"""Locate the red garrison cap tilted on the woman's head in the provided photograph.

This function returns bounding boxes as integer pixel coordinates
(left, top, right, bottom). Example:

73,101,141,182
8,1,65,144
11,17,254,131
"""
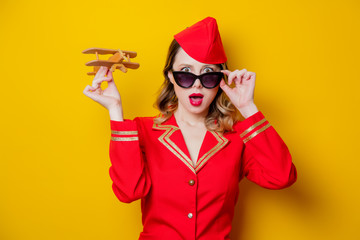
174,17,227,64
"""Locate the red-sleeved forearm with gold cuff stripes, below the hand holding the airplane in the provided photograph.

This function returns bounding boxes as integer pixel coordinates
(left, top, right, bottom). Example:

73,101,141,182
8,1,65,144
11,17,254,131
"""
109,120,151,203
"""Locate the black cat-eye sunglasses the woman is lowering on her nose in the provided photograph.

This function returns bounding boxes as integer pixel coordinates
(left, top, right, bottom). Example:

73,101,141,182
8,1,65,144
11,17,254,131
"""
172,71,224,88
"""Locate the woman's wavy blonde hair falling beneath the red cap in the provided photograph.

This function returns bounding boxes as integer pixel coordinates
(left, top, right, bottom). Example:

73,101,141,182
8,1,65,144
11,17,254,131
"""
154,39,239,133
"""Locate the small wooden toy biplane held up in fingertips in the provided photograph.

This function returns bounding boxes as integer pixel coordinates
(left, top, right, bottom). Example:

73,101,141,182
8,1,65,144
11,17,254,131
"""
82,48,140,75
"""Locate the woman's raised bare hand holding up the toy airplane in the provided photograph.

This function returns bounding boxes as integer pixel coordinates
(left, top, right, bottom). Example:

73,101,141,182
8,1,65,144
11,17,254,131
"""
83,66,122,120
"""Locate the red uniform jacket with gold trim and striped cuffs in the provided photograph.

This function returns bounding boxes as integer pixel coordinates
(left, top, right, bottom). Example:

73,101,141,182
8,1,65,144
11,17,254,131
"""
110,112,297,240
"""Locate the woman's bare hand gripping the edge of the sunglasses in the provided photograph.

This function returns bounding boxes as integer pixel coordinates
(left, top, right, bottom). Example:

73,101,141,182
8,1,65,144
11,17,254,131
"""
220,69,258,118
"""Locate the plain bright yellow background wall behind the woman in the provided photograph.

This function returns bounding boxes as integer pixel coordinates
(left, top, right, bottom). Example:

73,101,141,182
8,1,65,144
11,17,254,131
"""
0,0,360,240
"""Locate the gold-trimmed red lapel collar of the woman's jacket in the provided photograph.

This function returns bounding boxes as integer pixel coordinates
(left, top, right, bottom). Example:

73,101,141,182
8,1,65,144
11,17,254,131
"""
153,115,229,174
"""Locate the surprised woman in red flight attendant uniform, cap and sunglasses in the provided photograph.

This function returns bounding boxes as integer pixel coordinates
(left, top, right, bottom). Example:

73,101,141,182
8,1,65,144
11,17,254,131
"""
84,17,297,240
